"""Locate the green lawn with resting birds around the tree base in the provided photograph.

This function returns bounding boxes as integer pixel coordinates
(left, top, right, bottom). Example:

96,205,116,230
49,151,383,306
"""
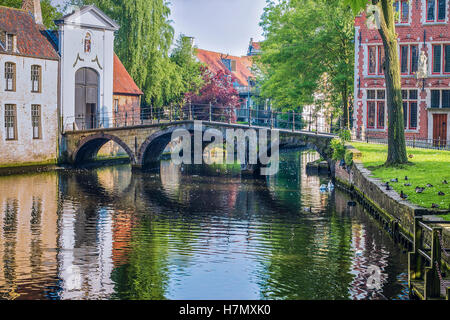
351,142,450,220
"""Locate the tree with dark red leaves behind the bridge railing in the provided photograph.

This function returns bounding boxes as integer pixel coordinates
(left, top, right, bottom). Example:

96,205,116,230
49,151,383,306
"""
185,67,240,123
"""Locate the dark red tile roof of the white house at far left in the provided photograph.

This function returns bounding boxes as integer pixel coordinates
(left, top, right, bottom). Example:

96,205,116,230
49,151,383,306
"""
0,6,59,60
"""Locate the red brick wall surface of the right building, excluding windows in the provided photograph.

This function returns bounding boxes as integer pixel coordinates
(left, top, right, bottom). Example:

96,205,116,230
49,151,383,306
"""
353,0,450,141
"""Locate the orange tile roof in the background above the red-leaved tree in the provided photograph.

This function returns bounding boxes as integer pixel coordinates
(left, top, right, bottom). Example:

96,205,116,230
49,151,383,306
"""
196,49,254,86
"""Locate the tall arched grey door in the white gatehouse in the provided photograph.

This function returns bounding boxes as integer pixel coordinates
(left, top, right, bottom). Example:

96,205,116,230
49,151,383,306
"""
75,68,99,129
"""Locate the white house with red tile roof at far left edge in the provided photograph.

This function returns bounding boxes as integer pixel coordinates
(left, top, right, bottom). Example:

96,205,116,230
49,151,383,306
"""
0,1,59,167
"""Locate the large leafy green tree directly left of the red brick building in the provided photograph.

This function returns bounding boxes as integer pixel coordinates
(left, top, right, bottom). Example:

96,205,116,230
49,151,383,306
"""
257,0,354,127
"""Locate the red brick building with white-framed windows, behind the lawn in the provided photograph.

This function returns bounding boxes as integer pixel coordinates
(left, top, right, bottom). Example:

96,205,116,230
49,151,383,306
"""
353,0,450,145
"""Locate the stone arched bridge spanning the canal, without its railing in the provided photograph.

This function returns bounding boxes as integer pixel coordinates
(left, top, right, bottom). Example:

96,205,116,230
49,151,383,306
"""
61,120,335,168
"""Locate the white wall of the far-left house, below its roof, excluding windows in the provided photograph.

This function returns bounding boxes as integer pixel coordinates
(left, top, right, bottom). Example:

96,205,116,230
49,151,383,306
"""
0,54,58,166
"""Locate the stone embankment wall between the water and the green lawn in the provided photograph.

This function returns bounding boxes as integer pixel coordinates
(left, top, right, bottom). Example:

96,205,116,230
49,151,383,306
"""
331,147,450,268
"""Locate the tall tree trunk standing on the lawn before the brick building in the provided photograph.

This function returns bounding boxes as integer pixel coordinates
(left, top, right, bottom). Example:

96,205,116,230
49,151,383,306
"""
344,0,408,166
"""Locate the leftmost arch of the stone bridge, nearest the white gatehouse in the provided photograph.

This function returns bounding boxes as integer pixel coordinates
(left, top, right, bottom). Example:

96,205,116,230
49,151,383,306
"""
71,133,136,165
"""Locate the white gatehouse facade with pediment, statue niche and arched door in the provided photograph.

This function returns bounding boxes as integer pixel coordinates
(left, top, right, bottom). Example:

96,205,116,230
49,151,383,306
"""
56,6,119,130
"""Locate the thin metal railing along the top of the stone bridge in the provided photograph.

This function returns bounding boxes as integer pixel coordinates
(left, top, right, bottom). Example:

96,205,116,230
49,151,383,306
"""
63,104,331,134
